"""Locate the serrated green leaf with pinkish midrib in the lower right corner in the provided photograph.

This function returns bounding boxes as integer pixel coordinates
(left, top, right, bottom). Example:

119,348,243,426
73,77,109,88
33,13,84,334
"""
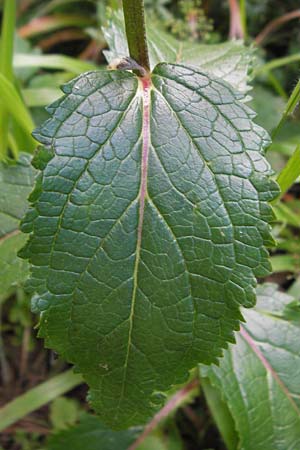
201,284,300,450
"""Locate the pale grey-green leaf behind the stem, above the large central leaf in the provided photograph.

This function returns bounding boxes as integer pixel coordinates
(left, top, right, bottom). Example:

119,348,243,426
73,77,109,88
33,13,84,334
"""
103,11,253,92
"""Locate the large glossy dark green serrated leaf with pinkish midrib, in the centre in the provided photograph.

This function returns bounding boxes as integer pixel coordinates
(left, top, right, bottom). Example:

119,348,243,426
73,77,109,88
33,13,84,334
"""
22,64,278,427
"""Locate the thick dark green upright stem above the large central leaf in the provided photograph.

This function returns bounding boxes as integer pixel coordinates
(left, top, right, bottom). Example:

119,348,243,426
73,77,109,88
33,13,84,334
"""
123,0,150,71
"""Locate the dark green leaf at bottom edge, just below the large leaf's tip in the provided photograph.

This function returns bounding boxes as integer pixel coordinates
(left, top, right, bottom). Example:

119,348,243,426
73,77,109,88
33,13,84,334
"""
47,414,137,450
